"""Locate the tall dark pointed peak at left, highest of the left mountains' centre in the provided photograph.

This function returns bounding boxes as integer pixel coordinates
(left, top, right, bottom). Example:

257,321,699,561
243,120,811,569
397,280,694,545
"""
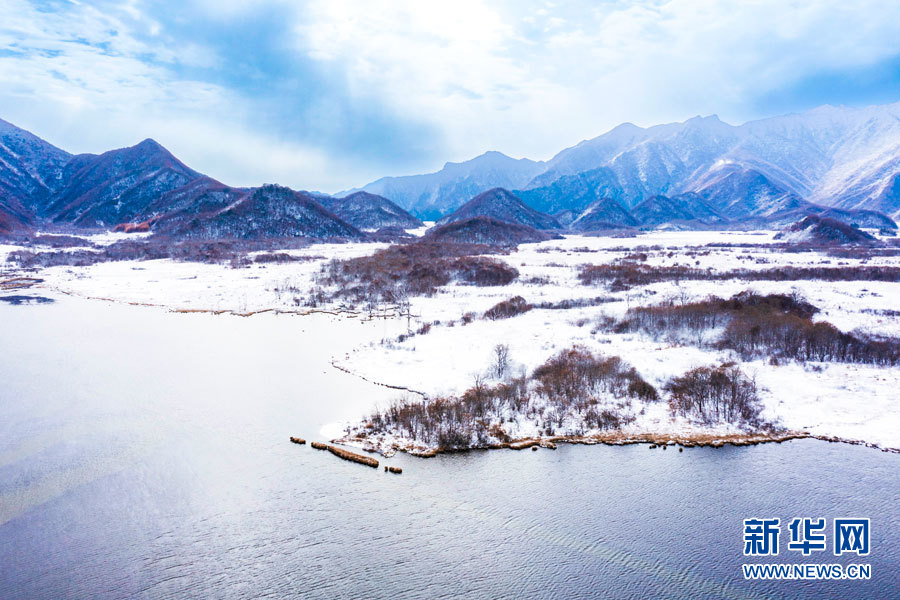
49,139,202,227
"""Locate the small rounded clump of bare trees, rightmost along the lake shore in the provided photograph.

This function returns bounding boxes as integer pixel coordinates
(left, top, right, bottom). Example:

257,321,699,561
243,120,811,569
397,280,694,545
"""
665,365,763,427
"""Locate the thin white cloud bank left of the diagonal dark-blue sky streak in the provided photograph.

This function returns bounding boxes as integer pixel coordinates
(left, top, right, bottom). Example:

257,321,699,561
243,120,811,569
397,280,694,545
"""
0,0,362,189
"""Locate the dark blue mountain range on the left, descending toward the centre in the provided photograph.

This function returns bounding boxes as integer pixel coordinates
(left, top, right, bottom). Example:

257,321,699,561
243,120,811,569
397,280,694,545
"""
0,120,421,239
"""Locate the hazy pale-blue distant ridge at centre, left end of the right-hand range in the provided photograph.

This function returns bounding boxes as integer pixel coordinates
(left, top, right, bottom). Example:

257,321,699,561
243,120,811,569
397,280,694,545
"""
338,152,544,221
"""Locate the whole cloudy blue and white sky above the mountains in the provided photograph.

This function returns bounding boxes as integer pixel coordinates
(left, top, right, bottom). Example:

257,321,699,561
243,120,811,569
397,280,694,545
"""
0,0,900,192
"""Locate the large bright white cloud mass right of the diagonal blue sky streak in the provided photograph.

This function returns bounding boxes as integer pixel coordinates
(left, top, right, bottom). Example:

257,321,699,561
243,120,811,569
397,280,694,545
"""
300,0,900,166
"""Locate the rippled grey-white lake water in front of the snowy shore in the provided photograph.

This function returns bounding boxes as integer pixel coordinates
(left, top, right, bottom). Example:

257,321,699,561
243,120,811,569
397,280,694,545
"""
0,297,900,599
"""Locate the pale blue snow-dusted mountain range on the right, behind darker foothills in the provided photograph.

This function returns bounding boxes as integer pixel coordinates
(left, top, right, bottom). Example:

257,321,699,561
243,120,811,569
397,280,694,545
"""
346,103,900,222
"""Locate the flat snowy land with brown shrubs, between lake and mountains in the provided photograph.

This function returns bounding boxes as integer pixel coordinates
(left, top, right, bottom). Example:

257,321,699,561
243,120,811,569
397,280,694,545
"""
0,229,900,456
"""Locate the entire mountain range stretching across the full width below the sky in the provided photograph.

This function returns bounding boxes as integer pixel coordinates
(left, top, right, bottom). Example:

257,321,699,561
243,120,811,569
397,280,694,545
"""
0,103,900,239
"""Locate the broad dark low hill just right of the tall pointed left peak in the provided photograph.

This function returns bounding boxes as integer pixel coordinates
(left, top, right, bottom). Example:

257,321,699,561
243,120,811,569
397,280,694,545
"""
155,185,362,239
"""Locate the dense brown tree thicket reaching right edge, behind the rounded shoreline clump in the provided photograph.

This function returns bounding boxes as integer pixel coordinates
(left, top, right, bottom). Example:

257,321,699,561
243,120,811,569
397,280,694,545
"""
611,292,900,365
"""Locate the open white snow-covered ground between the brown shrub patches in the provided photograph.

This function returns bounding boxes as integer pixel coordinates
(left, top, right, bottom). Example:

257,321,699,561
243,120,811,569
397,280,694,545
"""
0,232,900,449
